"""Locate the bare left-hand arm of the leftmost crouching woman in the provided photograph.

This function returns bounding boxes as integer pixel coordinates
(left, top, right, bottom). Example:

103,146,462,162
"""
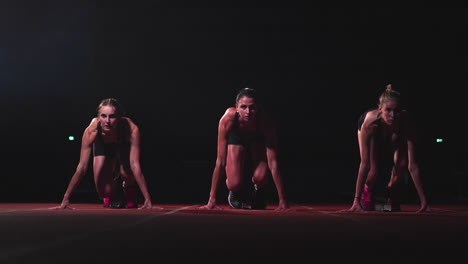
53,118,98,209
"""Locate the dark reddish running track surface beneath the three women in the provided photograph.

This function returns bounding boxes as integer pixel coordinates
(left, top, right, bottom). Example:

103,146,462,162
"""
0,203,468,264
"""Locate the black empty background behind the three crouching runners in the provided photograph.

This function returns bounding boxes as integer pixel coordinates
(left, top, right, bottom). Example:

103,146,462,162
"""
0,4,468,204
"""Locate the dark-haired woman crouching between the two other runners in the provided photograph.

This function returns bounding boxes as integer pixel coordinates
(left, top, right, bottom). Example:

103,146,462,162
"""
201,88,289,210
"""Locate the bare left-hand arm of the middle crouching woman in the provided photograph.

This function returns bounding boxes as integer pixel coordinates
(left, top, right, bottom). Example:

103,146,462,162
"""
202,108,235,209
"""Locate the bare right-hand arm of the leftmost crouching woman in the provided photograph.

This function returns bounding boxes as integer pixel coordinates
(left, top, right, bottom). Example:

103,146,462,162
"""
127,118,152,209
